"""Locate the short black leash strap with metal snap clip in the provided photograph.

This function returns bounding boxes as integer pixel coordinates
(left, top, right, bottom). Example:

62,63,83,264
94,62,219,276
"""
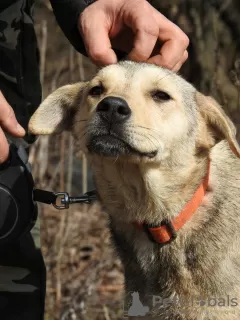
33,189,97,210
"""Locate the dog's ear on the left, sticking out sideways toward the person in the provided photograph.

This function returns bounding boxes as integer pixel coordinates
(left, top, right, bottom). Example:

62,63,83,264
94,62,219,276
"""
28,82,87,135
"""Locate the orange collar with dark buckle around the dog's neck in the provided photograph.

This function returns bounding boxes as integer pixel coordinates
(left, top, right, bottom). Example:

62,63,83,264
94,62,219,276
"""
136,161,210,245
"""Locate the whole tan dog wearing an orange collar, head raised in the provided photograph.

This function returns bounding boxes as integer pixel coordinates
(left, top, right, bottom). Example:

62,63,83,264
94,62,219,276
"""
29,62,240,320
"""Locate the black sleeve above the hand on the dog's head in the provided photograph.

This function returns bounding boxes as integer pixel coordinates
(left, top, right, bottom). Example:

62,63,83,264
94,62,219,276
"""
50,0,94,56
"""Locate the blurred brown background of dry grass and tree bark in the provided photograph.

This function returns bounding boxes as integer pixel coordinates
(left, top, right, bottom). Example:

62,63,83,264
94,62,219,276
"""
30,0,240,320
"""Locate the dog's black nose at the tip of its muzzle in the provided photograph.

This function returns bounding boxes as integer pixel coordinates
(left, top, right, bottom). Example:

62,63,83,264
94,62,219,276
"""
97,97,131,122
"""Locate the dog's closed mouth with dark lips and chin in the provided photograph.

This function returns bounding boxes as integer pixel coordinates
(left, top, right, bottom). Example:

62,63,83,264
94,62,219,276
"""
87,134,157,159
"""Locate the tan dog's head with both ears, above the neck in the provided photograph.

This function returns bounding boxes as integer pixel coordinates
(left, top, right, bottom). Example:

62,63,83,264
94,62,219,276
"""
29,62,240,163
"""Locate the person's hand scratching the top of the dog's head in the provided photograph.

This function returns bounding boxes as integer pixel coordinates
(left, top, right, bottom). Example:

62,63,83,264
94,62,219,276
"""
78,0,189,71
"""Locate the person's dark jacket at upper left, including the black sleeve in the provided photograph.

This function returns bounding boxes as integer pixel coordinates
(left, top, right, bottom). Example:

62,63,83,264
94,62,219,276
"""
0,0,94,142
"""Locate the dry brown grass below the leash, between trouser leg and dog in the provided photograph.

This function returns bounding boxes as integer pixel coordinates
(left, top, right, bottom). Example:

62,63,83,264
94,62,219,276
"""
41,204,123,320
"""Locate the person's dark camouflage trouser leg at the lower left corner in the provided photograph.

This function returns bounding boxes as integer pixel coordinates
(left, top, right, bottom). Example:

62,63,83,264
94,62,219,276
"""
0,219,46,320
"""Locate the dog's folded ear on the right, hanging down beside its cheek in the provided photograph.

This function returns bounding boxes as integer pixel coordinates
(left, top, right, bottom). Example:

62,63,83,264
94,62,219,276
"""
196,92,240,158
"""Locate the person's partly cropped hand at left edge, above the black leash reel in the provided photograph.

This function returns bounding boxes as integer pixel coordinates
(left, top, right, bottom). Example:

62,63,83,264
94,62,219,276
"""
0,91,25,163
